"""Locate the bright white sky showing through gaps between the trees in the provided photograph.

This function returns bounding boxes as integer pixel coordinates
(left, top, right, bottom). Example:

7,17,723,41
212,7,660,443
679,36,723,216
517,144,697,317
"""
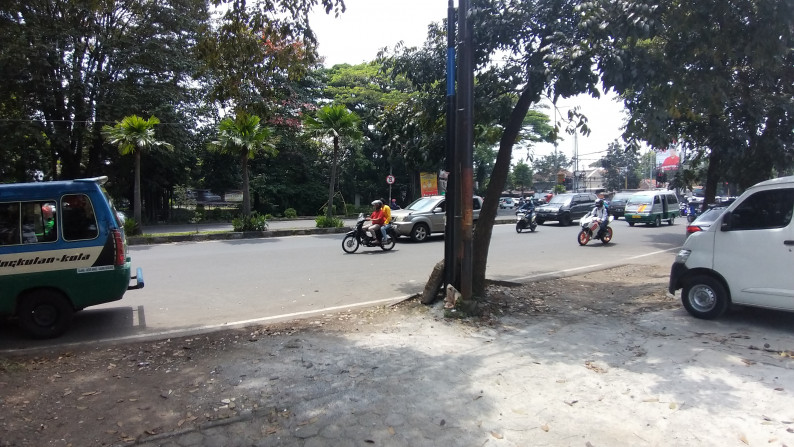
310,0,624,169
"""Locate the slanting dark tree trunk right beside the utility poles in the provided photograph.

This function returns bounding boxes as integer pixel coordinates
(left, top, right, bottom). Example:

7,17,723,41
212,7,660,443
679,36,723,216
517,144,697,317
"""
472,87,543,298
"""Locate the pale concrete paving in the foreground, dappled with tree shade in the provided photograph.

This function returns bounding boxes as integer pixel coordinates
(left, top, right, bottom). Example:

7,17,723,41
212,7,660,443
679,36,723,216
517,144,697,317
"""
119,265,794,447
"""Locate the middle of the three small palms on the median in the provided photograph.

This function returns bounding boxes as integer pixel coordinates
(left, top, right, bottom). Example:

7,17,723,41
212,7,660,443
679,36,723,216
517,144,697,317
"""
209,112,278,216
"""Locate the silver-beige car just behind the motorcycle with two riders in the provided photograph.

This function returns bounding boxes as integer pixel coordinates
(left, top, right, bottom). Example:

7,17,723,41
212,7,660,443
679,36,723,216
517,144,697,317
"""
391,196,482,242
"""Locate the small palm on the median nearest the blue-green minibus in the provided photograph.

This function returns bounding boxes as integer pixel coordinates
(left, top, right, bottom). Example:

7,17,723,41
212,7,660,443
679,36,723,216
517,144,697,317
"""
102,115,174,225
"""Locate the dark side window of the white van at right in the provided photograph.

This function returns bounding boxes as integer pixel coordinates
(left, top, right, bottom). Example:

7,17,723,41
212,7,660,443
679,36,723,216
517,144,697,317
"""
731,188,794,230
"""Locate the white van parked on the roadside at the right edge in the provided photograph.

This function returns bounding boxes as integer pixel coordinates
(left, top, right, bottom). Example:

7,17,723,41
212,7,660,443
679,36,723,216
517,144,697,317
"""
668,176,794,319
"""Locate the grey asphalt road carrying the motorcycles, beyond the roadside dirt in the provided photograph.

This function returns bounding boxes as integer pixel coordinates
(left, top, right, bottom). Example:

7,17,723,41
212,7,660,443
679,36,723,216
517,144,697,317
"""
0,220,685,349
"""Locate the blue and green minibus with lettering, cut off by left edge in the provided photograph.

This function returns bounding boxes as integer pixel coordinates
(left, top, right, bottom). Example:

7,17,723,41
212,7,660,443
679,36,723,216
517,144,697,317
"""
0,177,144,338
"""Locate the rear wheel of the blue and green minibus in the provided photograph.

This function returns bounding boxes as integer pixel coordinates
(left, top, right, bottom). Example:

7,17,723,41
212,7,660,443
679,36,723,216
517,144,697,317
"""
17,289,74,338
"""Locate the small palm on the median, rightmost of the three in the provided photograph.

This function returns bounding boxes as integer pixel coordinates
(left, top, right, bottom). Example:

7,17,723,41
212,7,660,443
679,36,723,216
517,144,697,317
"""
303,104,361,220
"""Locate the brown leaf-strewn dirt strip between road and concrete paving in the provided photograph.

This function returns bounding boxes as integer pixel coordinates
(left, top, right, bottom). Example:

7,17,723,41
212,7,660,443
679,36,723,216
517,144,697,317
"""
0,262,784,447
